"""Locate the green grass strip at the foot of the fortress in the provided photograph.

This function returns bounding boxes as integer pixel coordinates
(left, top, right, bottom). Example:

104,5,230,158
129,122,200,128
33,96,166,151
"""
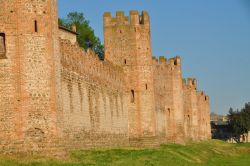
0,140,250,166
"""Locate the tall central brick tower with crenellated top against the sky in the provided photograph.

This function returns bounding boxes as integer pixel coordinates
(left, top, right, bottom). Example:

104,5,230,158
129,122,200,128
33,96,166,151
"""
104,11,156,138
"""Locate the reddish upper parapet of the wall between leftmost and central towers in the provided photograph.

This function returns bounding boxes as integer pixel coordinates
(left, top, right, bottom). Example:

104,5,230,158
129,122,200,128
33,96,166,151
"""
60,39,124,89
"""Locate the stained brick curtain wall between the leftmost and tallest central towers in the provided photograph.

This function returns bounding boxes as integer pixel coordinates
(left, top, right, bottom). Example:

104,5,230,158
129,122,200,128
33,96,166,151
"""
60,40,128,148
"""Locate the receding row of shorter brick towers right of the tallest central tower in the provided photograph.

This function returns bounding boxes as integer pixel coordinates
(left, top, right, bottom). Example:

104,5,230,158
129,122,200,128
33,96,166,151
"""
153,56,211,143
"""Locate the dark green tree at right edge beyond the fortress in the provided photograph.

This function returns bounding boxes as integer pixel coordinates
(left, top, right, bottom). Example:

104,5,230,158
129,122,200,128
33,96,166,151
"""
228,102,250,135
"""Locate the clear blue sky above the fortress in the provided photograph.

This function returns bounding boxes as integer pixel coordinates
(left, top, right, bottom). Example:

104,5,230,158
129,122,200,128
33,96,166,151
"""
58,0,250,114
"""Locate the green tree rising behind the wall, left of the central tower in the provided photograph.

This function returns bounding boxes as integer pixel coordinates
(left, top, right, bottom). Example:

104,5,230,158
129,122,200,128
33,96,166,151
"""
58,12,104,60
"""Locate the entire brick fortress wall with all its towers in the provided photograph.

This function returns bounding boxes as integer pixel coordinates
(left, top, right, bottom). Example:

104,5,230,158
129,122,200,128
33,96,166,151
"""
0,0,211,155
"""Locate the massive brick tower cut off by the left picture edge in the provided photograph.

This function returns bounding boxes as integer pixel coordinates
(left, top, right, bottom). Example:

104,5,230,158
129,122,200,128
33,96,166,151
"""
0,0,60,145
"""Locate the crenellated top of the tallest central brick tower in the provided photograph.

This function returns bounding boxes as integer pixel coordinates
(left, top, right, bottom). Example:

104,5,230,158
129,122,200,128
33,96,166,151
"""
103,10,150,26
